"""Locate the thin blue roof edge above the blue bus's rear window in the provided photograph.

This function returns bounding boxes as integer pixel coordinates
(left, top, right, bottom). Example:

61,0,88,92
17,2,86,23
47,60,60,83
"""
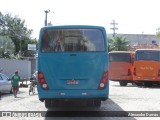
41,25,104,29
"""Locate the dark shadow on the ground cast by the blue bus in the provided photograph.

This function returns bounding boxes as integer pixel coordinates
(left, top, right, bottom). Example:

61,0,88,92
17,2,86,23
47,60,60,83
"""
45,99,135,120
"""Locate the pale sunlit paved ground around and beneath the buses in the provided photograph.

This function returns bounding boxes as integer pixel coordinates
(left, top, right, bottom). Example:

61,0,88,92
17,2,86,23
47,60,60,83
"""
0,81,160,120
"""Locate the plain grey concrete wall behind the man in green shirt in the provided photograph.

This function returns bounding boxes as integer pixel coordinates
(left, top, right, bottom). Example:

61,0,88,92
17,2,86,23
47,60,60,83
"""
0,59,31,79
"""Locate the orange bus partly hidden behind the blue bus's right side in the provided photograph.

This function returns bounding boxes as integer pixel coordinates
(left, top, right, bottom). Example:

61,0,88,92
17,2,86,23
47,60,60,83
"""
109,51,134,86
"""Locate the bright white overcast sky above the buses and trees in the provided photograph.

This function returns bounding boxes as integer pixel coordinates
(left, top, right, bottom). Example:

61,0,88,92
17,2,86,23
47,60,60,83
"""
0,0,160,38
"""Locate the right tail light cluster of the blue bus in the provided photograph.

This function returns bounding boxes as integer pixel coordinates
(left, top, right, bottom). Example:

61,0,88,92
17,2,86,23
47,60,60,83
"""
98,71,108,89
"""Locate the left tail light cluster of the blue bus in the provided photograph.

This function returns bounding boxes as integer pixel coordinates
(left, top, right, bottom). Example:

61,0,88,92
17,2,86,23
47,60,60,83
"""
38,72,49,90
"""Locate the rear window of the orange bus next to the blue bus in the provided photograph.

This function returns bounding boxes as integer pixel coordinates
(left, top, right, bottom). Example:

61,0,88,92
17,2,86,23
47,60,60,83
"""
109,53,131,62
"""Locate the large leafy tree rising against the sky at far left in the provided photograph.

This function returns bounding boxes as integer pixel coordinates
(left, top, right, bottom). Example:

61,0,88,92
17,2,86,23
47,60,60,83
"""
0,13,32,55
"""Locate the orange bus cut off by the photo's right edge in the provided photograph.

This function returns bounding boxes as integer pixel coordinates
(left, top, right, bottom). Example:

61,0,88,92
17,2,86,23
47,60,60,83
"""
133,49,160,87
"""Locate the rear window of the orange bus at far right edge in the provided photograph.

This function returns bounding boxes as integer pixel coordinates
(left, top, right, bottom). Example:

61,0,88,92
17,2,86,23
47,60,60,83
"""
135,51,160,61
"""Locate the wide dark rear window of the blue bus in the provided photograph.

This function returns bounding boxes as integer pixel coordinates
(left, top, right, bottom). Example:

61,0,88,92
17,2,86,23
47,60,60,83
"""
41,29,105,52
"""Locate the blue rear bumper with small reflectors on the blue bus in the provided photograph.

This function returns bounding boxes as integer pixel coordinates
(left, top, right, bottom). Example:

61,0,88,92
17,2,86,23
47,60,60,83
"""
38,89,109,101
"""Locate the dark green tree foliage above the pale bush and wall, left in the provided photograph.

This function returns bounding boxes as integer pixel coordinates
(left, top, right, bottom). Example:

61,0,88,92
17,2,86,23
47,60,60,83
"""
0,12,37,59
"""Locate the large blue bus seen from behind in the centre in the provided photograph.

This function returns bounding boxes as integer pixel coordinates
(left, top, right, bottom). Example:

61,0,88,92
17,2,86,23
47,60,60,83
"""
37,25,109,108
